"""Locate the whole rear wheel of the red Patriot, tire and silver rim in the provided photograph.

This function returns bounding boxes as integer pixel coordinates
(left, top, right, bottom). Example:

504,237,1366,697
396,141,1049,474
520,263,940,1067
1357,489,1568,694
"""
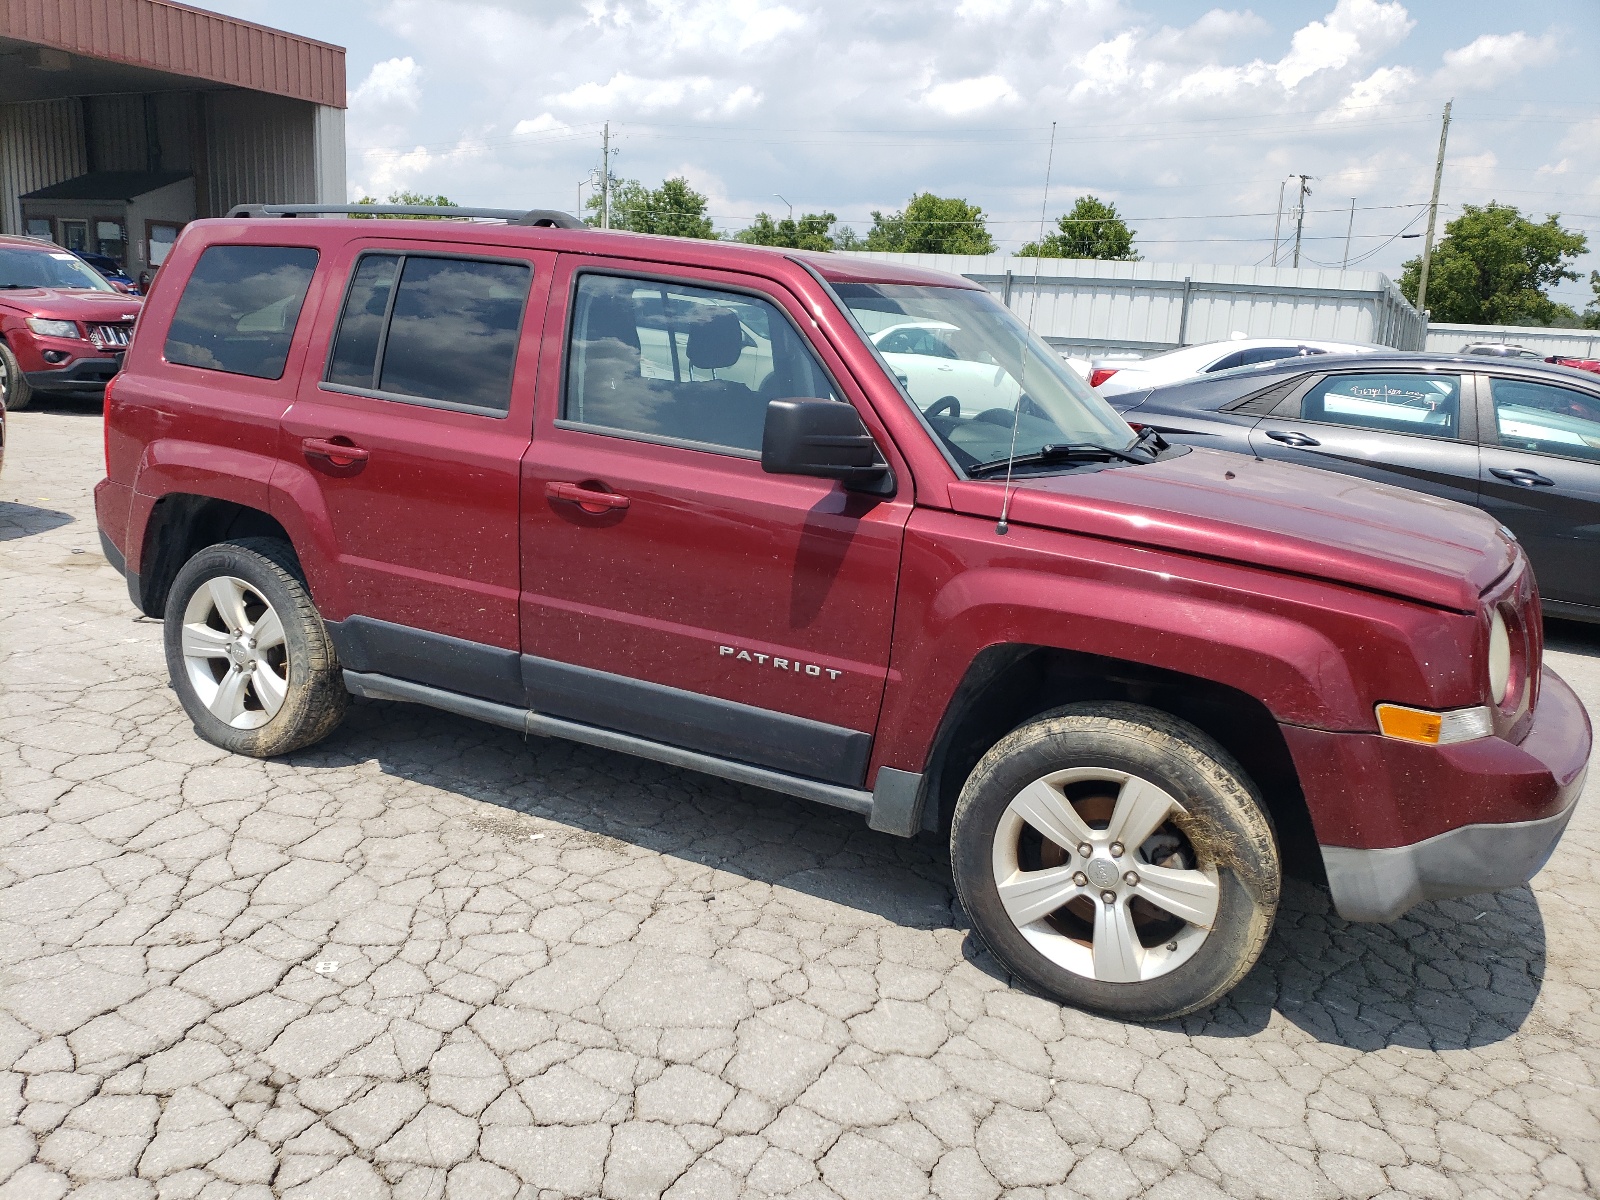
165,538,350,758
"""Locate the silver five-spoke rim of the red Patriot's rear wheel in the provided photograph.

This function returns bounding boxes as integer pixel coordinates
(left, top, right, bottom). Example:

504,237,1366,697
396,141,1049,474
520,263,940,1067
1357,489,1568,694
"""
182,576,290,730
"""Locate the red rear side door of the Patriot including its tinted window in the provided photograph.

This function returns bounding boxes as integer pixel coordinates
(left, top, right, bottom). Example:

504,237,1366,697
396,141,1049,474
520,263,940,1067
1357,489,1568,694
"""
284,237,555,706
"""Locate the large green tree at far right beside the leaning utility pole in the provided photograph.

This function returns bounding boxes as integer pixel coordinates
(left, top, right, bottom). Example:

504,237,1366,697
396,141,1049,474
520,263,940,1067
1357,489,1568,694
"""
1400,200,1589,325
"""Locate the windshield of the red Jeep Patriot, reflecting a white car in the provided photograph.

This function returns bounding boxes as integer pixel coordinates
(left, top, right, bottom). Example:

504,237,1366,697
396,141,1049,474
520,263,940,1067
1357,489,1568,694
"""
834,283,1147,477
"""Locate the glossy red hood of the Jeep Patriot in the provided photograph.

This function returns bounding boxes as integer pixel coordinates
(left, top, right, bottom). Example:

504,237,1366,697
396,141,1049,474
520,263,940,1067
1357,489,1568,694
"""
949,450,1517,613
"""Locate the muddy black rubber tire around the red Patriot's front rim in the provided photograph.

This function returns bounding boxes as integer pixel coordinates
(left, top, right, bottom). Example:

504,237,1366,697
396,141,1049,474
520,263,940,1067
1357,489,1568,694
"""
950,702,1282,1021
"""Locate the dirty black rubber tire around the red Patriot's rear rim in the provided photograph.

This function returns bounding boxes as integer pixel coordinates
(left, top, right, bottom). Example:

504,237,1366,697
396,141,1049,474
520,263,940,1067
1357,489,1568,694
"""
163,538,350,758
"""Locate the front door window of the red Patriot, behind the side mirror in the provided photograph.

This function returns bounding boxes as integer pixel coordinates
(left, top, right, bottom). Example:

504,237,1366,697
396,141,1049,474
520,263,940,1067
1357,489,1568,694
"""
563,275,838,453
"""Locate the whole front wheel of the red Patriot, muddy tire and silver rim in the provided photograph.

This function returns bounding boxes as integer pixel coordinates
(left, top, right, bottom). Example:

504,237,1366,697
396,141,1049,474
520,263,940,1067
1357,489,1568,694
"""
950,704,1282,1021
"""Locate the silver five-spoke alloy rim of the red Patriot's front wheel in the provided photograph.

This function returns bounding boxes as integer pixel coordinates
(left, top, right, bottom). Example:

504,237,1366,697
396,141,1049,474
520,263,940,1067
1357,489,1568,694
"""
992,766,1221,984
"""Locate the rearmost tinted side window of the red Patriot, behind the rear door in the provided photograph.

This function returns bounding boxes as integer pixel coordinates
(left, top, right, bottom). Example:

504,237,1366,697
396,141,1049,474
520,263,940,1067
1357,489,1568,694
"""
165,246,317,379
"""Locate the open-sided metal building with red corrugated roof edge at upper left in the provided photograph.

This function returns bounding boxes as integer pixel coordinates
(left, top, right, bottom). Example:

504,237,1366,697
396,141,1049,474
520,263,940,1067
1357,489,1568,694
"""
0,0,346,277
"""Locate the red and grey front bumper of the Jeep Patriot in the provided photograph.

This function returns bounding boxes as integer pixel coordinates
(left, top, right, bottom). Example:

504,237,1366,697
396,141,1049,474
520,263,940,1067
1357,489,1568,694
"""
1285,669,1592,922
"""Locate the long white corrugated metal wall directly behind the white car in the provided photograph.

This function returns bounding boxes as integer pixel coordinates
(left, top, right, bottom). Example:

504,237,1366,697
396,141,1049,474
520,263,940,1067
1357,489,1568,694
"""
861,253,1422,352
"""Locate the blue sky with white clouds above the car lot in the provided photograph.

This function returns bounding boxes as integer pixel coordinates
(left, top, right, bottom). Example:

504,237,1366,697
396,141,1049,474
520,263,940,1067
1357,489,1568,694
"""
205,0,1600,306
